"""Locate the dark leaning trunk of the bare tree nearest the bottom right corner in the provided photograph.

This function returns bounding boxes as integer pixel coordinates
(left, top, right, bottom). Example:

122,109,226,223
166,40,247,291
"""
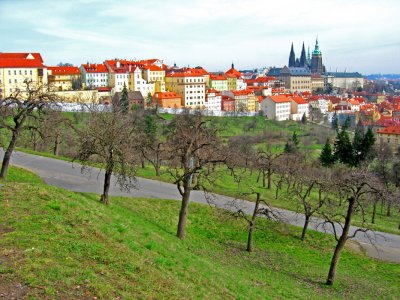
326,197,356,285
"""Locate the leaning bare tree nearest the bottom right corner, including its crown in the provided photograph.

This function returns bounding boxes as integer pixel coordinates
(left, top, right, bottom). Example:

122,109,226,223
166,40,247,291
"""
323,168,383,285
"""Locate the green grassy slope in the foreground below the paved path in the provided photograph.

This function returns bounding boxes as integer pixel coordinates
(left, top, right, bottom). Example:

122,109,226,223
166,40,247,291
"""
0,168,400,299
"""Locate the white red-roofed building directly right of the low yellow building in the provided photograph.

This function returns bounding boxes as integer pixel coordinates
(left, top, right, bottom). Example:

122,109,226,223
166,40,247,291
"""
80,63,108,88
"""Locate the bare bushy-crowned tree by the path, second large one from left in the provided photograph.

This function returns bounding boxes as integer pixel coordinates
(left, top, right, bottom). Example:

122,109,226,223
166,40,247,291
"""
75,108,138,204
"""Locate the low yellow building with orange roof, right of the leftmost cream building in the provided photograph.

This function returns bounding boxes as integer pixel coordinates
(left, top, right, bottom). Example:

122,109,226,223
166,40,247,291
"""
47,66,82,91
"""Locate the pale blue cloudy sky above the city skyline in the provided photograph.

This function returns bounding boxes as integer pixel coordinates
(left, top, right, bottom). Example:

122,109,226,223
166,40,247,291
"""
0,0,400,74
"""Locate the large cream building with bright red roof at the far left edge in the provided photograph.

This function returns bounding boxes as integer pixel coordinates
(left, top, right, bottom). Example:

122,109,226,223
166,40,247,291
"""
0,53,47,97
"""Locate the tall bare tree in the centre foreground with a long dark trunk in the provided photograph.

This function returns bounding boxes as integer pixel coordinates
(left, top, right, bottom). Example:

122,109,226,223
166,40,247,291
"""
166,112,226,239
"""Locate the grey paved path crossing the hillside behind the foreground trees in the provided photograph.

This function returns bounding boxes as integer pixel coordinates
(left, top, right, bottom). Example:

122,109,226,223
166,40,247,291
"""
0,149,400,263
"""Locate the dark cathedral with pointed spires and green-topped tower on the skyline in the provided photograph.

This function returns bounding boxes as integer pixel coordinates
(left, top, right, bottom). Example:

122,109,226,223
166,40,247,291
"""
289,38,325,74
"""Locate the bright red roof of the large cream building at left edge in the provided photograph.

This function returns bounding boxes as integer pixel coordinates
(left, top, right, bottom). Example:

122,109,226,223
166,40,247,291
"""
0,53,45,68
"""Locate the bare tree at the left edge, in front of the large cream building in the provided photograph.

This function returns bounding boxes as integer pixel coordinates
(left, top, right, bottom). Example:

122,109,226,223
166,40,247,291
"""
0,80,58,179
